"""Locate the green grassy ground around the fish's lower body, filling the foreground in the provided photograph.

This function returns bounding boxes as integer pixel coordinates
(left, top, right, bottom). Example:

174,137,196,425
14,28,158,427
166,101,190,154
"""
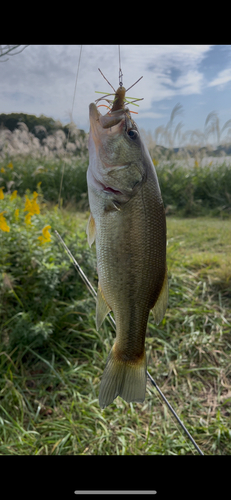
0,192,231,455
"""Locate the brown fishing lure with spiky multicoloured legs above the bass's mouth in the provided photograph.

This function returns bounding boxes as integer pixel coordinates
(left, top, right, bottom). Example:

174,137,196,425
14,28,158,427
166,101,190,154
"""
95,68,143,114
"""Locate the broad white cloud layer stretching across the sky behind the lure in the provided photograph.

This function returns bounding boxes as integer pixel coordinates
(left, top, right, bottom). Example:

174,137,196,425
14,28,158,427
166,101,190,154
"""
0,45,212,130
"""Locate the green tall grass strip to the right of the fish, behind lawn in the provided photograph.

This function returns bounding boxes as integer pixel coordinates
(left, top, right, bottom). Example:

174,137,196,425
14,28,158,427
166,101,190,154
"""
155,161,231,216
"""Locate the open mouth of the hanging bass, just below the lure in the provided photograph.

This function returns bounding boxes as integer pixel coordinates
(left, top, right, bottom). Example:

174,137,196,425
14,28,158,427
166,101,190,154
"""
89,103,126,129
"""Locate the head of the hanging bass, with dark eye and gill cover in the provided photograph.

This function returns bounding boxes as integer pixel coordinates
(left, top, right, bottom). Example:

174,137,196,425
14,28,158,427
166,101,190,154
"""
87,103,148,200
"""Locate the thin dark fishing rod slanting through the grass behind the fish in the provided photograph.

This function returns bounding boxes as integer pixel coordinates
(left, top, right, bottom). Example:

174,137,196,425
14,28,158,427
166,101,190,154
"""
55,229,204,455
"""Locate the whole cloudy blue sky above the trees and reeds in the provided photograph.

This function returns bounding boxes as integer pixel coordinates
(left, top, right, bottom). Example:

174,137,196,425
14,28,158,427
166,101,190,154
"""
0,45,231,147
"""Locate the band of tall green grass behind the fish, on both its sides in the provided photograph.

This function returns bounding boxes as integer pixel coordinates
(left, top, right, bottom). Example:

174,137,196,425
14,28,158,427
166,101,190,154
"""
0,155,231,217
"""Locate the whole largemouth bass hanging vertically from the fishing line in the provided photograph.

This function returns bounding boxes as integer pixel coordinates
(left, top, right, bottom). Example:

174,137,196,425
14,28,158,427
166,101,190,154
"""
87,98,168,408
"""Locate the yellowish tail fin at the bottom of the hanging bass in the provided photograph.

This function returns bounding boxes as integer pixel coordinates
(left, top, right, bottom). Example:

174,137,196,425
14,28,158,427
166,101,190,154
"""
99,345,147,408
